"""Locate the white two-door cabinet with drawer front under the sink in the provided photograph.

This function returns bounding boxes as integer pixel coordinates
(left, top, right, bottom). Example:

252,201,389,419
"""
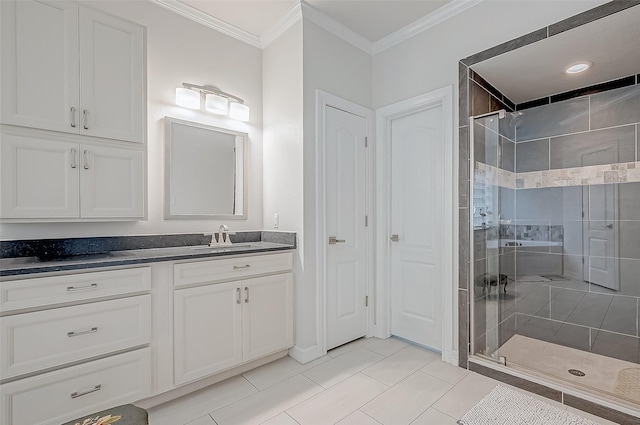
173,253,293,385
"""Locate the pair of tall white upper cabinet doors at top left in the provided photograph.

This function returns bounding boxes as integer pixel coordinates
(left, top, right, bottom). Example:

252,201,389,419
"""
1,0,146,143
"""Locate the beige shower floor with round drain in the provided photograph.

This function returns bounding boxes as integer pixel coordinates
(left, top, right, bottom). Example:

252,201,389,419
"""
499,335,640,408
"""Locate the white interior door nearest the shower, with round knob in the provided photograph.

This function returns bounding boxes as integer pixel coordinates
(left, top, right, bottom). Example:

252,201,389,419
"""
391,105,445,350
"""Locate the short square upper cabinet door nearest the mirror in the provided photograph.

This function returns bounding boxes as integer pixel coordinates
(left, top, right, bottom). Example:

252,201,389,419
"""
80,145,145,218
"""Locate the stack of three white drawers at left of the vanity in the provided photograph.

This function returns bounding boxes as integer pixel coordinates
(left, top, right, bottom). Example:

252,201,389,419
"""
0,266,153,425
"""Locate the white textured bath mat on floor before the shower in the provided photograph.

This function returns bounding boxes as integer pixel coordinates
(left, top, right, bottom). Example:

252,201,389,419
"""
458,385,598,425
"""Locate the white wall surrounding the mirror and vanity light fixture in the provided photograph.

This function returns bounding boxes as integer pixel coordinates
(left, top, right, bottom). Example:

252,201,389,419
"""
0,1,263,240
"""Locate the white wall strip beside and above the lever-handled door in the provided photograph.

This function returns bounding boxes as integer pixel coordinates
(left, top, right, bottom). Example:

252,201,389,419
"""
296,19,371,348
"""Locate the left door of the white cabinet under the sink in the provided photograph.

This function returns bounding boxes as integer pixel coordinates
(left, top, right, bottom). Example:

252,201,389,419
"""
173,282,242,385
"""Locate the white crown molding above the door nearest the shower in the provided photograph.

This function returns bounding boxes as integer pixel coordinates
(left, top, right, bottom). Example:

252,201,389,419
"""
371,0,483,55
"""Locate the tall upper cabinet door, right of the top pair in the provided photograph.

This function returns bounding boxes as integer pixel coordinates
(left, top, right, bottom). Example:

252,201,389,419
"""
79,6,146,143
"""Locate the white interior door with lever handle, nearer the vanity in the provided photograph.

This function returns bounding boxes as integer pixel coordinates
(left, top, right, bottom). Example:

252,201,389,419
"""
324,107,367,350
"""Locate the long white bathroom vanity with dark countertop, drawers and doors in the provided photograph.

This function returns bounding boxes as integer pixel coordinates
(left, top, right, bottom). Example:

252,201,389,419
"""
0,232,296,425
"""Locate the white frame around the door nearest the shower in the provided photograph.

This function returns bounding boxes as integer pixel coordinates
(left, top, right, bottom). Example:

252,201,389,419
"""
374,86,458,366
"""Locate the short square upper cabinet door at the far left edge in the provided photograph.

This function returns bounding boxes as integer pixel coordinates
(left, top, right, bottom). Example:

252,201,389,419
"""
1,135,79,218
